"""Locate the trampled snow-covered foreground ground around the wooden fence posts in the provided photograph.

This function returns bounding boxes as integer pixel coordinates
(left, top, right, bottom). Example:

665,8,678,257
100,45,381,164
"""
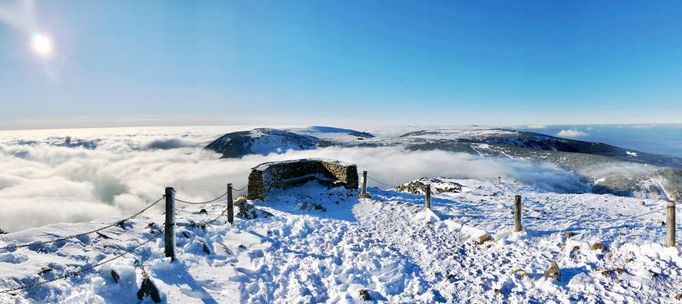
0,179,682,303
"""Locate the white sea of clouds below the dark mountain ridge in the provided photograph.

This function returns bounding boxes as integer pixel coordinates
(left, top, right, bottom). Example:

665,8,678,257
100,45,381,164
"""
0,127,586,231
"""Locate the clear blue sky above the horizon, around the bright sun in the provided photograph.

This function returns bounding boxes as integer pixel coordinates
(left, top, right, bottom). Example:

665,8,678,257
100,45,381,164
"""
0,0,682,129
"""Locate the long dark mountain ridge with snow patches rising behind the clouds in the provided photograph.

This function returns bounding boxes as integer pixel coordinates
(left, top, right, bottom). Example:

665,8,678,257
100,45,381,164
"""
206,127,682,200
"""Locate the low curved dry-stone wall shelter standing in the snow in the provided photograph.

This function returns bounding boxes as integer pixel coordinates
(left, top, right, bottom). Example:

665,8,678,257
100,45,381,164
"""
246,159,358,200
